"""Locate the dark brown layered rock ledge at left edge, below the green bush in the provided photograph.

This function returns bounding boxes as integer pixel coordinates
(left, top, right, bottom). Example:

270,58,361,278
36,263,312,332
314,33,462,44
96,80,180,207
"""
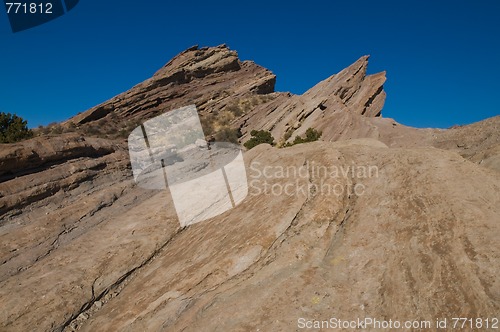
0,135,128,218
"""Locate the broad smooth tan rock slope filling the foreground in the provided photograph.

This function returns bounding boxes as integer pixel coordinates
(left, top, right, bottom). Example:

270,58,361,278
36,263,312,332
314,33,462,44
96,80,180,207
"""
0,140,500,331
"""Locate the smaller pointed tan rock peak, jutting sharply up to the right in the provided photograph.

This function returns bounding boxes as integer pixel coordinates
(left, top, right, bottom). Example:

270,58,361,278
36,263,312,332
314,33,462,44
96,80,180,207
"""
238,56,386,143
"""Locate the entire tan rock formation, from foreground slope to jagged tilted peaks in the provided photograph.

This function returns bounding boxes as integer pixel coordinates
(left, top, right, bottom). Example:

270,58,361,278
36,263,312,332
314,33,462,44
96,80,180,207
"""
0,46,500,331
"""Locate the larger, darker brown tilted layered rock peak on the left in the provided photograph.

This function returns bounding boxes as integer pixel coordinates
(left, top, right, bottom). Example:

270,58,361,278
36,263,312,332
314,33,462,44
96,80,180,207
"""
70,45,276,125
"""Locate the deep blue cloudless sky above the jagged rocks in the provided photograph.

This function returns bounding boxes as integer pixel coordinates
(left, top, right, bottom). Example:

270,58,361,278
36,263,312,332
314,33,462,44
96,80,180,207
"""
0,0,500,128
